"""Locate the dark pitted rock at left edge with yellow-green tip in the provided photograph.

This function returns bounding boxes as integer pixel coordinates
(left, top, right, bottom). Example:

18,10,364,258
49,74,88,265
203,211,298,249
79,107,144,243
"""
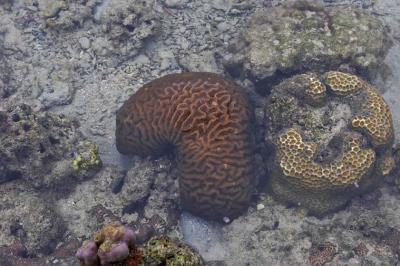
0,104,102,189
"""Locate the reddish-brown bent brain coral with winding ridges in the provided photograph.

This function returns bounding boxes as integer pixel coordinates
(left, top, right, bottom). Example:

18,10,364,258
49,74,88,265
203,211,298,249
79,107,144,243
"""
116,73,254,219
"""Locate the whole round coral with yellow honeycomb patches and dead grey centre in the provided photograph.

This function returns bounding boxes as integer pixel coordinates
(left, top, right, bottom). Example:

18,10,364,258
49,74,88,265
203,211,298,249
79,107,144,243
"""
266,71,393,215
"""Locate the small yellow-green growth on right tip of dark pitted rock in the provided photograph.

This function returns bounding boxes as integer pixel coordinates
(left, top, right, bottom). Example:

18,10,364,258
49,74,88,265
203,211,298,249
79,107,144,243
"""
72,140,102,172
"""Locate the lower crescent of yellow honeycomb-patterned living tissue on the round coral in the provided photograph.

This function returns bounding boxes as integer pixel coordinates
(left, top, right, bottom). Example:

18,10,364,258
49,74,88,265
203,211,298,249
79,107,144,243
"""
278,129,375,189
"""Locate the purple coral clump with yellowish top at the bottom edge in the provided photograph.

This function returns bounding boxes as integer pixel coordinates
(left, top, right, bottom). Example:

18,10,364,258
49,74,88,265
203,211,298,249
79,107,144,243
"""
76,224,136,266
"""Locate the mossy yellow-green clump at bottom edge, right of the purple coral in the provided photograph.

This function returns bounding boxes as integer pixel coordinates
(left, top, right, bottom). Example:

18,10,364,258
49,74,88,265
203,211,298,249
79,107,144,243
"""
144,236,204,266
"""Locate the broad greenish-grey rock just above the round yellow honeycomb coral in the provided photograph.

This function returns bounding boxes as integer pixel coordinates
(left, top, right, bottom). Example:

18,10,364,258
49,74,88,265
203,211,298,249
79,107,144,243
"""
223,1,391,86
